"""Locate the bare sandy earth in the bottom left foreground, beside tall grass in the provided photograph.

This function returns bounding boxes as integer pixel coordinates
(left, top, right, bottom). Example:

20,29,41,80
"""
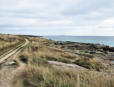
0,52,25,87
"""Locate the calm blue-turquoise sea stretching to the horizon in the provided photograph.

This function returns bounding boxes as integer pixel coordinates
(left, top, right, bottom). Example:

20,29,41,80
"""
44,36,114,47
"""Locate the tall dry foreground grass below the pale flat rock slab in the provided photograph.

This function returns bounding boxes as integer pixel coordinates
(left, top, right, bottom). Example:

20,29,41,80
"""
13,55,114,87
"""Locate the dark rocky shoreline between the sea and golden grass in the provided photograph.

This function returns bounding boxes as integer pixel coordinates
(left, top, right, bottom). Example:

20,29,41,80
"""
45,40,114,61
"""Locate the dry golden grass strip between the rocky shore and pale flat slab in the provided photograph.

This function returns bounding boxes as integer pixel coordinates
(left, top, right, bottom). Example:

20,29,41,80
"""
23,42,77,63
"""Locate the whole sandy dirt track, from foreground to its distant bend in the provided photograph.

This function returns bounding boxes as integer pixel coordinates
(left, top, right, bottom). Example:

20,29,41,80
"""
0,40,29,87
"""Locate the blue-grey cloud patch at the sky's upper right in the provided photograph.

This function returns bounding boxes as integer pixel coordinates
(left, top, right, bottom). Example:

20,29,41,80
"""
63,0,114,16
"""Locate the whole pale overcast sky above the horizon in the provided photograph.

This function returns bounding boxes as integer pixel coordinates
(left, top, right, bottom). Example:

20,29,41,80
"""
0,0,114,36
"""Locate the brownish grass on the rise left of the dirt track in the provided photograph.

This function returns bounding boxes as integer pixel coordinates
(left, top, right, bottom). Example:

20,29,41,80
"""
0,34,24,55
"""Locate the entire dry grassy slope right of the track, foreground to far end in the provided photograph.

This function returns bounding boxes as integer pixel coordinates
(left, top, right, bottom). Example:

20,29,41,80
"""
13,37,114,87
